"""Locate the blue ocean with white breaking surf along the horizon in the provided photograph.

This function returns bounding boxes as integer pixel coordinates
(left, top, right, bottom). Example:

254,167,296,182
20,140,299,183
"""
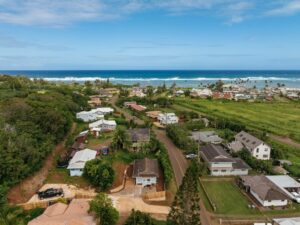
0,70,300,88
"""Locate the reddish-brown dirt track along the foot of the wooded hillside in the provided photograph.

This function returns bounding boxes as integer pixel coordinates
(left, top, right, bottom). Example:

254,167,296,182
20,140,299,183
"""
7,123,76,204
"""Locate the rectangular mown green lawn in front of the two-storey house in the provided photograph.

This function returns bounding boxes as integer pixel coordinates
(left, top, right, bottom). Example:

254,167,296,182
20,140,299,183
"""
202,180,259,216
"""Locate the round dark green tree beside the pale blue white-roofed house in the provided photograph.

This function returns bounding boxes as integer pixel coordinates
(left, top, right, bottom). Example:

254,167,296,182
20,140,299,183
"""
84,158,115,190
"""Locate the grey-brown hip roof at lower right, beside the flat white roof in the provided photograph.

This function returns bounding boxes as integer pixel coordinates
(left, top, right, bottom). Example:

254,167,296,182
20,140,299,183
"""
241,176,289,201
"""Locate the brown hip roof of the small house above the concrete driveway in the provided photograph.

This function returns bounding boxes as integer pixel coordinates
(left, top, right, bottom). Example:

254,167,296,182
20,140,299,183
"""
132,158,159,178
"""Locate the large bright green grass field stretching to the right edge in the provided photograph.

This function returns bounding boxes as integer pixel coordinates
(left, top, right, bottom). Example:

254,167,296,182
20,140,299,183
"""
173,98,300,141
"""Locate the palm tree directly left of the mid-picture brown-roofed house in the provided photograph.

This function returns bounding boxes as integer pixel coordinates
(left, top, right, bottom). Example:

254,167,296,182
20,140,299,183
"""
111,127,131,150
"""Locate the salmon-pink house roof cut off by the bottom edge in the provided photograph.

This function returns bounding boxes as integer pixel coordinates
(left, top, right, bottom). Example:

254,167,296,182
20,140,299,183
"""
28,199,97,225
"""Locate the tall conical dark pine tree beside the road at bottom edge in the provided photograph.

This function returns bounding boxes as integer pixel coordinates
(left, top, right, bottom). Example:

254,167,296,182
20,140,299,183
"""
167,160,203,225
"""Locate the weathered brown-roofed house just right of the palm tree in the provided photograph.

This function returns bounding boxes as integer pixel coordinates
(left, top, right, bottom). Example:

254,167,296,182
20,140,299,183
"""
127,128,150,151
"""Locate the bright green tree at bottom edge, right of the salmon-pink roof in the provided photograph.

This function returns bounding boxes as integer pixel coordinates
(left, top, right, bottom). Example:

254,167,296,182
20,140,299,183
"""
89,193,119,225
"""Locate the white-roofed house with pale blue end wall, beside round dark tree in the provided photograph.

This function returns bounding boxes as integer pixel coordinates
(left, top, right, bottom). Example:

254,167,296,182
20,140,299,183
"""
67,148,97,177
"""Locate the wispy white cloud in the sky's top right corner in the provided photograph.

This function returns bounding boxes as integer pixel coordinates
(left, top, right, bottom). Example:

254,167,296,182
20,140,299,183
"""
266,0,300,16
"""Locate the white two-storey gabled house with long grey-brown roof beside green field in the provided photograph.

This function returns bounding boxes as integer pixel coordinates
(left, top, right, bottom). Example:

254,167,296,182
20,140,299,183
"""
235,131,271,160
